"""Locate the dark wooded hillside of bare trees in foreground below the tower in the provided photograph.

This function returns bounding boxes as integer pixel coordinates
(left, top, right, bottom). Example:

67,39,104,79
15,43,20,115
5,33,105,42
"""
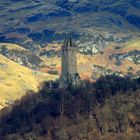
0,76,140,140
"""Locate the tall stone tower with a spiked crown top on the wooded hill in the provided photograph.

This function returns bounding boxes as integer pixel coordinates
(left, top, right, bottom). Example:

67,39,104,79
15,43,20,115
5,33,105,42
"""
60,35,80,88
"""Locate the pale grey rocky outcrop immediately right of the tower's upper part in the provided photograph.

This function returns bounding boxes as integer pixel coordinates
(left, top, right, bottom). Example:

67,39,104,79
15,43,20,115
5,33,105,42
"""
77,32,132,55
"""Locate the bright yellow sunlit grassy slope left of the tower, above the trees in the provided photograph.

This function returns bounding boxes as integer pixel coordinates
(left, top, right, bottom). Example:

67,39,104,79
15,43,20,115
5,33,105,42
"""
0,55,56,109
